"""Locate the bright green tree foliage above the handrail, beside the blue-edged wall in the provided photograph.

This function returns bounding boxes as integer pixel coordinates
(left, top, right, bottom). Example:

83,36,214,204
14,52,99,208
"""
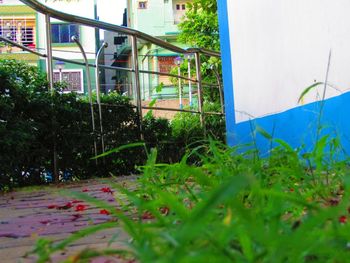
178,0,220,51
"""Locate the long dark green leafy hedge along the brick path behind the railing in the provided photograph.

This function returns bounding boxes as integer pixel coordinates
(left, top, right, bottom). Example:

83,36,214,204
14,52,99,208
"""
0,60,224,190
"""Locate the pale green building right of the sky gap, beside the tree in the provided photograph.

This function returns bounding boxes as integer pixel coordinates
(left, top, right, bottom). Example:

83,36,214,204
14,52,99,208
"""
127,0,191,100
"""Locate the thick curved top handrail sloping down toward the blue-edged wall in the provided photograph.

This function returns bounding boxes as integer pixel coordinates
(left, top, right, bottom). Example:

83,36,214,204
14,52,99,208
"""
20,0,221,57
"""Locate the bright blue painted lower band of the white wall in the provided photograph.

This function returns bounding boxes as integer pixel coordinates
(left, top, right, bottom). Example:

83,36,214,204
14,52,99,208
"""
227,92,350,155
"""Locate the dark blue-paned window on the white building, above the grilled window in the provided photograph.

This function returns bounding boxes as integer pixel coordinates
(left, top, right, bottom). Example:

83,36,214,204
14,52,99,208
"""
51,24,79,43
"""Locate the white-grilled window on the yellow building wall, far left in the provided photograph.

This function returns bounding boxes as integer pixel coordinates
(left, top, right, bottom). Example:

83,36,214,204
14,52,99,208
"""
0,18,35,48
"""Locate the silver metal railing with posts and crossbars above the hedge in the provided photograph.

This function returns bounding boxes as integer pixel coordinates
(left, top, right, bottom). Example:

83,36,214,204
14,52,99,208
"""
4,0,223,144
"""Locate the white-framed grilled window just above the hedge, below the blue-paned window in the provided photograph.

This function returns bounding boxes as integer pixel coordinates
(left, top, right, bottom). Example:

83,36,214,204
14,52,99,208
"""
53,69,84,93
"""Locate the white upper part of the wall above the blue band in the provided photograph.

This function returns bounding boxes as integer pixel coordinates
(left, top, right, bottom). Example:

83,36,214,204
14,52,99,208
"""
227,0,350,122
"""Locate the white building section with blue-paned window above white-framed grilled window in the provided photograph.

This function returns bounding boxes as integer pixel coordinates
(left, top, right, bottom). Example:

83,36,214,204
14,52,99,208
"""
38,0,96,93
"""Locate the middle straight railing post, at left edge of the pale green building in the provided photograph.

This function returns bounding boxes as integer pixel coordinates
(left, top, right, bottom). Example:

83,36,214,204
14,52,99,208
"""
131,36,144,140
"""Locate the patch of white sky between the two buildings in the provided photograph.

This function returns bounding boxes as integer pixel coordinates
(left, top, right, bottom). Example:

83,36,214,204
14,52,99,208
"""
97,0,126,25
